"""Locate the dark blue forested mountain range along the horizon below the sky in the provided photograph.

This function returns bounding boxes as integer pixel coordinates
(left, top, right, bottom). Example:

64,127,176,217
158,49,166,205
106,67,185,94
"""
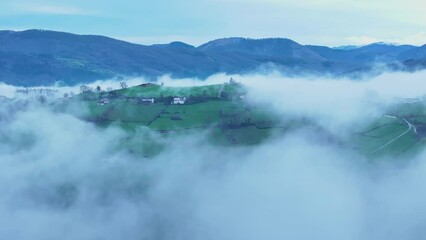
0,30,426,86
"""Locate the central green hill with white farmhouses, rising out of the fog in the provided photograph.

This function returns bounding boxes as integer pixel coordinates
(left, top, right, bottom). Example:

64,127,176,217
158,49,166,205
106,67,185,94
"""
55,82,304,155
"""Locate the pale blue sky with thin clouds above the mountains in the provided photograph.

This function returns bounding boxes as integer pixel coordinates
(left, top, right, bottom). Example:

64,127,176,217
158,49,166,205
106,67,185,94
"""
0,0,426,46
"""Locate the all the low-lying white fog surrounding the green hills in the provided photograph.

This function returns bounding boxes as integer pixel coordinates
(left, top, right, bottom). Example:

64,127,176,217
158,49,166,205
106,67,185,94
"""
0,72,426,240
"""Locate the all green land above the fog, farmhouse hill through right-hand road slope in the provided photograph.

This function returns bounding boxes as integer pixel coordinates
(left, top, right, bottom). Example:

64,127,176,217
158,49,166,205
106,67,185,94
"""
55,82,426,159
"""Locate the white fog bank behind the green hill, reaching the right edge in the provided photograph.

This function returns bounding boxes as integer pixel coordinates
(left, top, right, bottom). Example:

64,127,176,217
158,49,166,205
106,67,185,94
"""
158,71,426,131
